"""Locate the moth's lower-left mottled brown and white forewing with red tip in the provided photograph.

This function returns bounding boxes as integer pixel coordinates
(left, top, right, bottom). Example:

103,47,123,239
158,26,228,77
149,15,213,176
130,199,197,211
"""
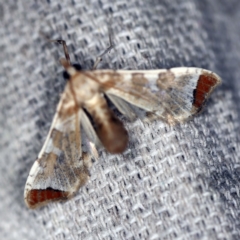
24,82,91,208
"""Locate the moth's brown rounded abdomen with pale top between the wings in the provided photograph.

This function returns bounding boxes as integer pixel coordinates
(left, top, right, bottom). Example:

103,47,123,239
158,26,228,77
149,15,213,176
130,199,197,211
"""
86,94,128,153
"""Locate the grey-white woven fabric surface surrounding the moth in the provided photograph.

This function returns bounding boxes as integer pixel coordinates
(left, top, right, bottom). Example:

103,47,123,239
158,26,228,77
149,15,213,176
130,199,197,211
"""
0,0,240,239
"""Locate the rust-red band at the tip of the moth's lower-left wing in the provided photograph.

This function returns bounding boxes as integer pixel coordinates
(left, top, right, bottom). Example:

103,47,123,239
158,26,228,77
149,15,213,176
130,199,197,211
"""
25,188,69,208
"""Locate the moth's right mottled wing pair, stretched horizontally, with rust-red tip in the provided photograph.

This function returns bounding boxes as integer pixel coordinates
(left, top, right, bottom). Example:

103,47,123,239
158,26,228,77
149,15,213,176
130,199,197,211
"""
90,67,221,124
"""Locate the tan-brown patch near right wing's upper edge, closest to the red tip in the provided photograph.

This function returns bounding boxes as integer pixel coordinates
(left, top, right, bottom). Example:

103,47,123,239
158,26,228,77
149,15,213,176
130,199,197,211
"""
156,70,176,90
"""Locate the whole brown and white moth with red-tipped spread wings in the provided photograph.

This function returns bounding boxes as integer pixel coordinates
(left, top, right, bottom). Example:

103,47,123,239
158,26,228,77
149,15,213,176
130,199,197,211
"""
24,40,221,209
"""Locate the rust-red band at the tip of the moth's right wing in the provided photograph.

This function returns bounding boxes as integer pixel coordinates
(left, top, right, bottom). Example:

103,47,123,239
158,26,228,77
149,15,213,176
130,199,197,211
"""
193,73,219,110
